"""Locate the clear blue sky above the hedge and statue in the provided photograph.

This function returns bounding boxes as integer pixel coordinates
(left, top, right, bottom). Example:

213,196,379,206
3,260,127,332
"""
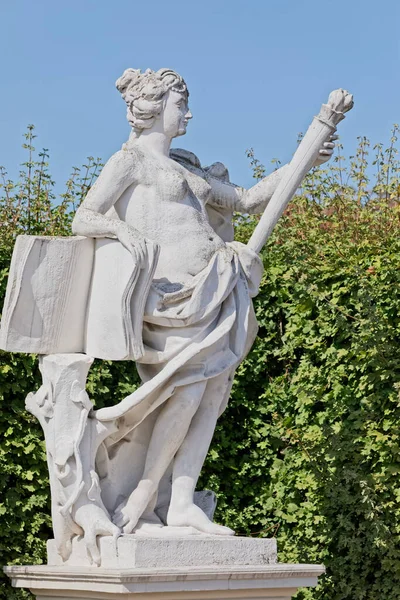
0,0,400,189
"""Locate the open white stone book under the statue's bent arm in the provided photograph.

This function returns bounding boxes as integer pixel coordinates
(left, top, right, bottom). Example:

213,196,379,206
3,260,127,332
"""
0,235,158,360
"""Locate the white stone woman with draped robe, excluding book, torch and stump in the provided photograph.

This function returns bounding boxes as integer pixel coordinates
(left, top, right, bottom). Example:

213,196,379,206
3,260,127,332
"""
73,69,334,535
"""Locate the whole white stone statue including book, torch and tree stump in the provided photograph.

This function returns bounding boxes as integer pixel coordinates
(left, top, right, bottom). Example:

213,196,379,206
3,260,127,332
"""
1,69,352,564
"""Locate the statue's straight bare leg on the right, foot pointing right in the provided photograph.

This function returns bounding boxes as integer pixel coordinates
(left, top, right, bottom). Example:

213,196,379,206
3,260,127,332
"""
167,373,234,535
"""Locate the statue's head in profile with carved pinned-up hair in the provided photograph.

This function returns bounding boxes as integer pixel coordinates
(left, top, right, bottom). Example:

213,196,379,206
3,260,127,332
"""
116,69,192,138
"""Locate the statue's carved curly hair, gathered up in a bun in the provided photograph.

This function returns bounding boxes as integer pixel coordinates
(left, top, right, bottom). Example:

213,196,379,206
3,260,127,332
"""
115,69,189,135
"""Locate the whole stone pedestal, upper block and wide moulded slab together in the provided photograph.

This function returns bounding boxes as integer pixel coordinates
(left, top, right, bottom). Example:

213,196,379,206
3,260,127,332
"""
5,527,324,600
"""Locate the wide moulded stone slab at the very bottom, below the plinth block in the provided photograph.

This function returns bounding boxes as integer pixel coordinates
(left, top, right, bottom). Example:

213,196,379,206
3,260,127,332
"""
5,564,324,600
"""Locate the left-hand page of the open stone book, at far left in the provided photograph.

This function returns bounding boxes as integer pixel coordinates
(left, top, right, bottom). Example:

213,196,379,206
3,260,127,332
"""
0,235,94,354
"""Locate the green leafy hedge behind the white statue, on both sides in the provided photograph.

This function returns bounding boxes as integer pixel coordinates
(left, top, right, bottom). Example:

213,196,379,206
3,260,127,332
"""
0,126,400,600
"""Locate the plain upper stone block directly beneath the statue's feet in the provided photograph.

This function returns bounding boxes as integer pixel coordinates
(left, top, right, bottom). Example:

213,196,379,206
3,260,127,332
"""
47,527,277,569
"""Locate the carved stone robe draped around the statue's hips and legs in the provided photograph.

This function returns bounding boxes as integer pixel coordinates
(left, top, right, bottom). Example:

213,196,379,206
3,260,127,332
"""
95,152,262,518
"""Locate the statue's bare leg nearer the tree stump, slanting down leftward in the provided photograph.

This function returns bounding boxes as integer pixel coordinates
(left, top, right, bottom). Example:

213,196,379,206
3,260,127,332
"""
113,381,207,533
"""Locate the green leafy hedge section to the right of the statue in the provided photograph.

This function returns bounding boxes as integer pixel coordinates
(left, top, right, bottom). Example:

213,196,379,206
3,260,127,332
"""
203,127,400,600
